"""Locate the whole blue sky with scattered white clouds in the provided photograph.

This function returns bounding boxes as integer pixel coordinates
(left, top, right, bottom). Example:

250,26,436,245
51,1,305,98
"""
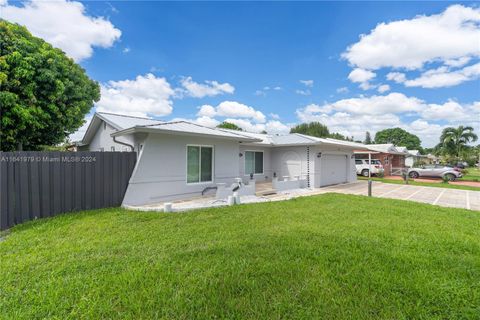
0,0,480,146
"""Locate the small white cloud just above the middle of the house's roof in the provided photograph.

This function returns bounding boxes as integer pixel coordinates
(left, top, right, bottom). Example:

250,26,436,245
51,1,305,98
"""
197,101,266,123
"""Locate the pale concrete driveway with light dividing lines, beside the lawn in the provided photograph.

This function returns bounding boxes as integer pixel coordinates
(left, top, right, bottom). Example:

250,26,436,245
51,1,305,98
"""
323,181,480,210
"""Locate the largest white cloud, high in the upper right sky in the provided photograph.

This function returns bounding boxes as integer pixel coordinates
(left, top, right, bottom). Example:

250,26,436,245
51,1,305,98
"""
342,5,480,70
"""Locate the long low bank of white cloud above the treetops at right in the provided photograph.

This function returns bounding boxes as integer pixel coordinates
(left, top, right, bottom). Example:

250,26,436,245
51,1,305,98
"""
296,93,480,147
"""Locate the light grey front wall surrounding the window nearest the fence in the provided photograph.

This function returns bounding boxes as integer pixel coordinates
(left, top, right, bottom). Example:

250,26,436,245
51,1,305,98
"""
123,134,240,205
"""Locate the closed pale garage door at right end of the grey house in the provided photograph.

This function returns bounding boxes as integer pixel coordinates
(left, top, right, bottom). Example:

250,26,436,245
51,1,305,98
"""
320,154,347,187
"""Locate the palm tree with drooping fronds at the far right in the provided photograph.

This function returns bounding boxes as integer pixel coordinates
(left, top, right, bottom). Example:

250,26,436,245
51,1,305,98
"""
439,126,478,160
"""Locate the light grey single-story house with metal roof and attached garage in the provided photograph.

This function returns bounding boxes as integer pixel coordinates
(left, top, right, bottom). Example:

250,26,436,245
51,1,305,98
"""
82,113,364,205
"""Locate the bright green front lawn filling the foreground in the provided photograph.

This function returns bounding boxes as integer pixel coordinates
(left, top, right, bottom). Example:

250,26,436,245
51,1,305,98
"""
0,194,480,319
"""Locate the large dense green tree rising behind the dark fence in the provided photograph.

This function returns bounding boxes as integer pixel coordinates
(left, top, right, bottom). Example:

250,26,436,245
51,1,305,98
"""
0,17,100,151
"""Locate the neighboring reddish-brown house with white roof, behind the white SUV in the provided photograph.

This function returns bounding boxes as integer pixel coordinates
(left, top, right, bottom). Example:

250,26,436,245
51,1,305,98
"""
355,143,408,176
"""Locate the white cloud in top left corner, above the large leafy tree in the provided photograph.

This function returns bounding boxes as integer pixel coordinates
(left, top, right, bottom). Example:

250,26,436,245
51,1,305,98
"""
0,0,121,61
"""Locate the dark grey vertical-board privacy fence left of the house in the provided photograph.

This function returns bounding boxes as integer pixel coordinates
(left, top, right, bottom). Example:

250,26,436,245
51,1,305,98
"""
0,152,137,230
